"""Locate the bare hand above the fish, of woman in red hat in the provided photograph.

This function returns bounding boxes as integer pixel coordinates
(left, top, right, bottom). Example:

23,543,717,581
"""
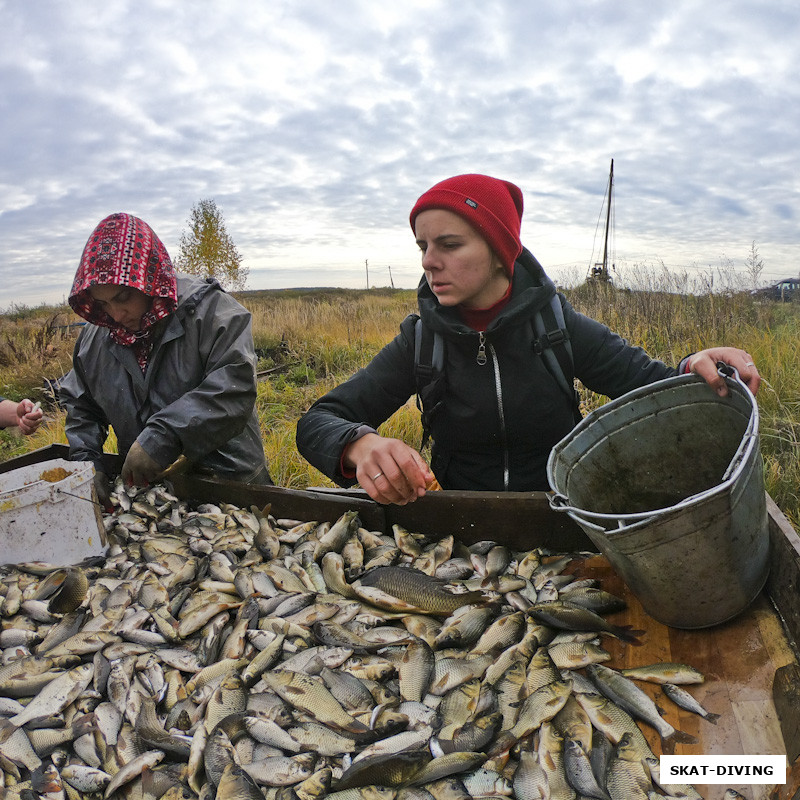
344,433,433,506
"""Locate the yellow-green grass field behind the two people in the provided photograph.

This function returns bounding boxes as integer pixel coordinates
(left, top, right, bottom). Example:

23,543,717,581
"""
0,282,800,528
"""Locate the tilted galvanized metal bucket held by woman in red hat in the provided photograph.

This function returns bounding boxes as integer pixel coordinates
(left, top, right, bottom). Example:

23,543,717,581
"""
547,365,769,628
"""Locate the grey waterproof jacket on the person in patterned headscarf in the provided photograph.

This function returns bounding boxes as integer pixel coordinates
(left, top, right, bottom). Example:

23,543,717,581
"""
59,274,270,483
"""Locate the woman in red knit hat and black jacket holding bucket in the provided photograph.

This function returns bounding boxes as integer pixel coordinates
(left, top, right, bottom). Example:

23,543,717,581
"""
297,174,760,504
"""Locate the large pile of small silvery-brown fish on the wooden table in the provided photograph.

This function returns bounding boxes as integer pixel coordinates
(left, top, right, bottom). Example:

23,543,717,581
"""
0,483,715,800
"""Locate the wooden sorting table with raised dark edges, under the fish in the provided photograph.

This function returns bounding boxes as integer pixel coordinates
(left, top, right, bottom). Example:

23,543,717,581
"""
0,445,800,800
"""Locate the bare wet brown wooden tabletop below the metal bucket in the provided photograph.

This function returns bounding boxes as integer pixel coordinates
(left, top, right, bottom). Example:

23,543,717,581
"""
574,556,800,800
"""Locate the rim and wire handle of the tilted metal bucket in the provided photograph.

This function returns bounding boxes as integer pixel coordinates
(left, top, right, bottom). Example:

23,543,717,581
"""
547,362,759,532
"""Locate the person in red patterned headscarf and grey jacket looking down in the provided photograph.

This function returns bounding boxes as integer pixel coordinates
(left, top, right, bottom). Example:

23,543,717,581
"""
59,209,272,498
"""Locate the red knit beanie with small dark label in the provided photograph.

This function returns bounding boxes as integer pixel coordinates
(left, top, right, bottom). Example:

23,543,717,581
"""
410,175,522,277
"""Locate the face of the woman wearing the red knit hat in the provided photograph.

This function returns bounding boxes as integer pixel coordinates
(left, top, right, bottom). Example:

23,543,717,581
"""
414,208,509,308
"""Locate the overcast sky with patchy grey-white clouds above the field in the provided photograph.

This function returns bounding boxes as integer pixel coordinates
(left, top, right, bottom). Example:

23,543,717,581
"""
0,0,800,309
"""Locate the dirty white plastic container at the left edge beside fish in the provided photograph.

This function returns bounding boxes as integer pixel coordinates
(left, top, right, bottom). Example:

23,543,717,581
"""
0,458,106,566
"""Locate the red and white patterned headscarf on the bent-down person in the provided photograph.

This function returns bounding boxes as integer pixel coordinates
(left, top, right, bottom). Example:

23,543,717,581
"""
69,214,178,370
